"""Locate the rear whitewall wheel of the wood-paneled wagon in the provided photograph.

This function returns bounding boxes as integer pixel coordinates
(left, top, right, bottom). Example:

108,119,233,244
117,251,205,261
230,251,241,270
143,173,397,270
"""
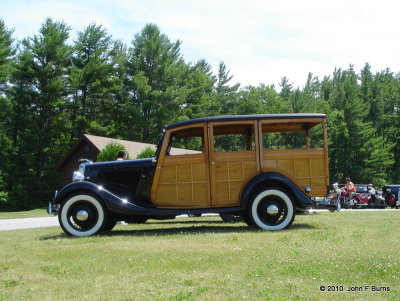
246,188,295,231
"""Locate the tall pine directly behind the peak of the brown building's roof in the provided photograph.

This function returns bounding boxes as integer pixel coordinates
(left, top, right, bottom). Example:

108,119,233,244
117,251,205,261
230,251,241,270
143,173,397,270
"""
70,23,117,139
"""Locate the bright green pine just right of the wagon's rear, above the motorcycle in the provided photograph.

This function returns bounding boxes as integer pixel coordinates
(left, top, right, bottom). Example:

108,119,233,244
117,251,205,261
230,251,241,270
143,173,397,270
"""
329,66,394,184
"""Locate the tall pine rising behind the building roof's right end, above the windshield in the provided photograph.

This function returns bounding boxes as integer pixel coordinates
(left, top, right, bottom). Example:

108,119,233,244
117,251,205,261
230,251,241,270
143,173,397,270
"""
127,24,186,143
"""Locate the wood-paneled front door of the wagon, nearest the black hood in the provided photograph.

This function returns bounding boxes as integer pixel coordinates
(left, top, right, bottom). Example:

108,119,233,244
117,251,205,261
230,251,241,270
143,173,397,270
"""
151,123,211,208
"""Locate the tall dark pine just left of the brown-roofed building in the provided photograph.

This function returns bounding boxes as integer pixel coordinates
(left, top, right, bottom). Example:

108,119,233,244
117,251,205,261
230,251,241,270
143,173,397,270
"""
10,18,71,206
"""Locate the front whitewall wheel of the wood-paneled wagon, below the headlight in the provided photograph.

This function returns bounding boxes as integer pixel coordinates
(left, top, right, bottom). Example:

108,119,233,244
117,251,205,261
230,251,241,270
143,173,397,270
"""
58,194,107,236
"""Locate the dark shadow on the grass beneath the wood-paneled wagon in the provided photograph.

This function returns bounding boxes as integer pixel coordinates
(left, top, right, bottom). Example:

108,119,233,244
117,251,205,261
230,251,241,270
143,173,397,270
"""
40,220,315,240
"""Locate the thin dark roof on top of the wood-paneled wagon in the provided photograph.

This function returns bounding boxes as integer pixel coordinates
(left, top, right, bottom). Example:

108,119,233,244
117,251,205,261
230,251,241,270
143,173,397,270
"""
165,113,326,129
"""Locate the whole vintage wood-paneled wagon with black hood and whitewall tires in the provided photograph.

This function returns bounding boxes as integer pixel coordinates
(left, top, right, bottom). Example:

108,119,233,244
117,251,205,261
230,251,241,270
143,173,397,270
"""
49,114,329,236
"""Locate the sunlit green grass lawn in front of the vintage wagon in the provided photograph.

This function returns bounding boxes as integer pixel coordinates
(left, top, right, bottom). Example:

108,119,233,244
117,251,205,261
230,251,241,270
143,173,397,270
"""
0,211,400,300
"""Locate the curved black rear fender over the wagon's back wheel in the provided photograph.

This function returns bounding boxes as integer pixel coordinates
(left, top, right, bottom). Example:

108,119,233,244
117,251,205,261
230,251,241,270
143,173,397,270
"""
241,172,314,209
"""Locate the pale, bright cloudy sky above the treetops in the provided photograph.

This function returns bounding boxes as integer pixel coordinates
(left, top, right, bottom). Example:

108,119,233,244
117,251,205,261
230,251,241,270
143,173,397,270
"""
0,0,400,87
